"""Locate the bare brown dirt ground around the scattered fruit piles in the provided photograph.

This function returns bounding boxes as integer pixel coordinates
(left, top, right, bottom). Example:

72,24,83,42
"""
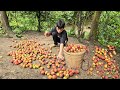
0,31,120,79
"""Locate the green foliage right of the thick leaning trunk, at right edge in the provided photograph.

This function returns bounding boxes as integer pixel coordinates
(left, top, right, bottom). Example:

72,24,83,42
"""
98,11,120,48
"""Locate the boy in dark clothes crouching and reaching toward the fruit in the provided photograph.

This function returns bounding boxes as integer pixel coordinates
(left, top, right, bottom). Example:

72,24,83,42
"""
44,20,68,59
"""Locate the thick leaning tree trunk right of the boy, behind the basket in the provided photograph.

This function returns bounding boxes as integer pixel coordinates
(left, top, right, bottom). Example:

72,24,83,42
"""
89,11,102,41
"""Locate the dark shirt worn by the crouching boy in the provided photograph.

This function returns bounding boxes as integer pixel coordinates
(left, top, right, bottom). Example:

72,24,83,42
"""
50,27,68,43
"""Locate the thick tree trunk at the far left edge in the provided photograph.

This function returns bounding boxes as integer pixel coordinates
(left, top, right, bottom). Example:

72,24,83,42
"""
0,11,13,37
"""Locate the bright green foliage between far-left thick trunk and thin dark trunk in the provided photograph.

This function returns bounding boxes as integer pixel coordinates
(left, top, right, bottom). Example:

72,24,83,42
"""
7,11,38,33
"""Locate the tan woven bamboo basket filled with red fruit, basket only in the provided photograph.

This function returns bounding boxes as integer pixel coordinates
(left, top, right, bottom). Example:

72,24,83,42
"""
63,44,86,68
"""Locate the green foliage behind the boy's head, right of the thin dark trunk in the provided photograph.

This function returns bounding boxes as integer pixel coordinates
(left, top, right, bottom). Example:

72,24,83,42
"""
41,11,74,31
